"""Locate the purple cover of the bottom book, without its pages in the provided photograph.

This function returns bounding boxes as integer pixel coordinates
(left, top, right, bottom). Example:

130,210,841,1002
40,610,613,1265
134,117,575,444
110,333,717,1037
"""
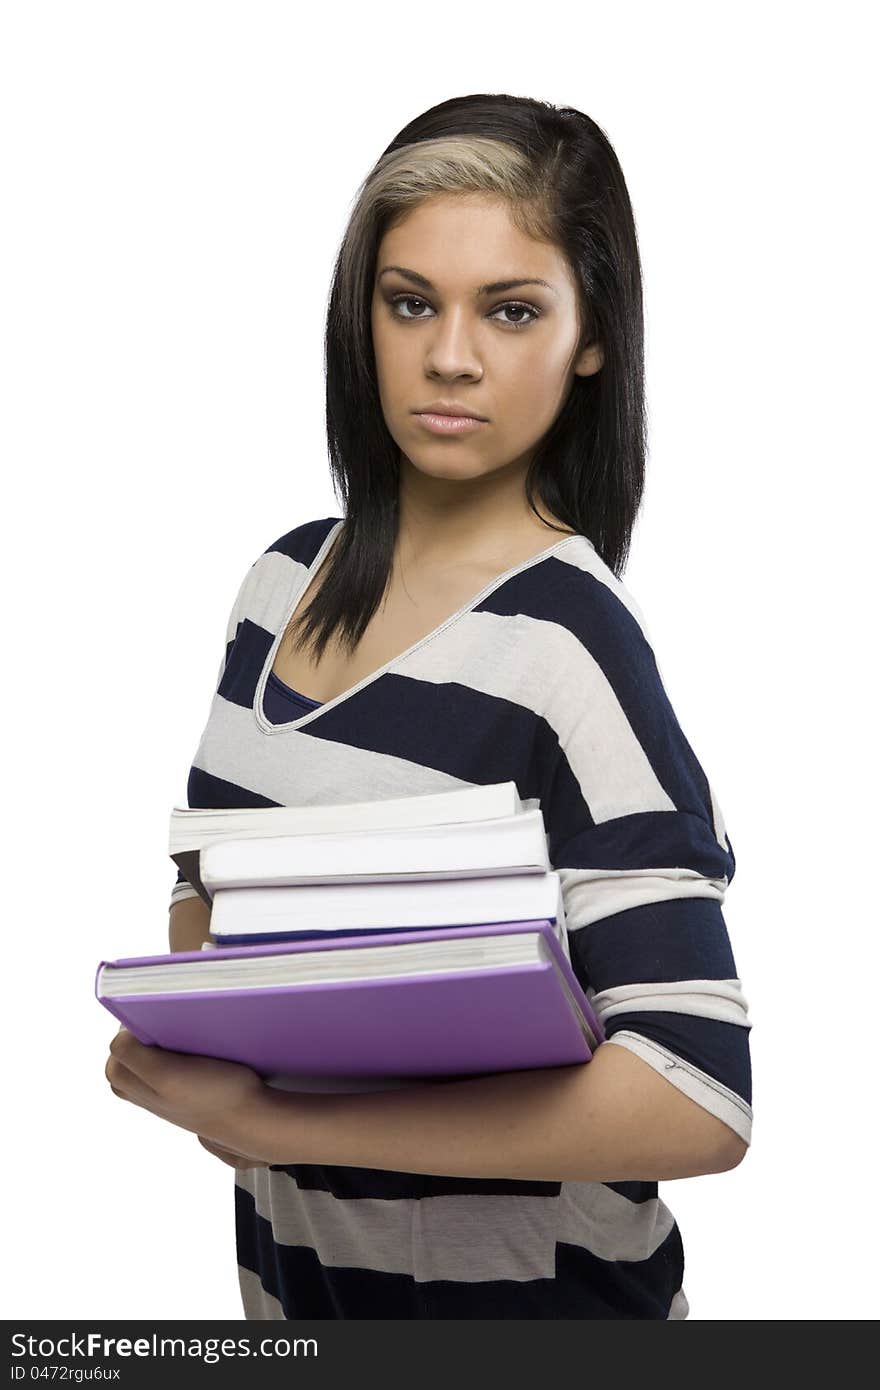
95,922,605,1076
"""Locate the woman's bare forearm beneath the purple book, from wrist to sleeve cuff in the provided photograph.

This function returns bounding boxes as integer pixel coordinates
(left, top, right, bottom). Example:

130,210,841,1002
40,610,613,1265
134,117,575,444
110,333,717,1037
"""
232,1043,747,1182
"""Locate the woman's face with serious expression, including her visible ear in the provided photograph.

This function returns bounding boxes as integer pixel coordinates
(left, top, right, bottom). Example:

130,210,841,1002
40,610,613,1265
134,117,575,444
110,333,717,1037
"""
371,195,602,489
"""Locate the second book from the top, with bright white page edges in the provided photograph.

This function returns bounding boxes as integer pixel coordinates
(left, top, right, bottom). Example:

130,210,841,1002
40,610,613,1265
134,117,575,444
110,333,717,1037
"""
200,810,551,895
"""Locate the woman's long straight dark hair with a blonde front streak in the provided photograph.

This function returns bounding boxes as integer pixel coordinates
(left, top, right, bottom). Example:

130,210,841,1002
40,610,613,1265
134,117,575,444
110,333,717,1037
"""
288,93,646,660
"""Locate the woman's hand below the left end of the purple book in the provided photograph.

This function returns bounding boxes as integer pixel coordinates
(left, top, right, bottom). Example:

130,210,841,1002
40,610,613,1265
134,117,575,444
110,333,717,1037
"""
104,1027,266,1163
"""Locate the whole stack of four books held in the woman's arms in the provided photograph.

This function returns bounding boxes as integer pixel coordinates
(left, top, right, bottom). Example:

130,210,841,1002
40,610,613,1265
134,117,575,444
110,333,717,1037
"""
96,783,603,1088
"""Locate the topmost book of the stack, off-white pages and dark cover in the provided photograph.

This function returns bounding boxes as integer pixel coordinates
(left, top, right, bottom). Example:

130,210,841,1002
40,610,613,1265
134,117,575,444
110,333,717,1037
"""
168,781,524,908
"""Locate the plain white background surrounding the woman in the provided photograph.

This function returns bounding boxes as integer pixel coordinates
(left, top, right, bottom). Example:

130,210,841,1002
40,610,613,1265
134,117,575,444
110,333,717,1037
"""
0,0,879,1319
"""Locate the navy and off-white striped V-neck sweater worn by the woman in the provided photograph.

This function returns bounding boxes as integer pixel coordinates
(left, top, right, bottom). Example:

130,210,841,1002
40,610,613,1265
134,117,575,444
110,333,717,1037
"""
171,517,752,1319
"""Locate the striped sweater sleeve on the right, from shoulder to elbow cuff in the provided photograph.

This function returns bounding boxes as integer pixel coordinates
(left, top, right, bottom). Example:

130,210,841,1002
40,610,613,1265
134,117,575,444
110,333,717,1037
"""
541,575,752,1144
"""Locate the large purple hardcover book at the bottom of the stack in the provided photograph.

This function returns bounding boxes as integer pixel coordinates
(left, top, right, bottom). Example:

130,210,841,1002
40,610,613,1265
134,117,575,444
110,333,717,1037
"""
95,922,605,1077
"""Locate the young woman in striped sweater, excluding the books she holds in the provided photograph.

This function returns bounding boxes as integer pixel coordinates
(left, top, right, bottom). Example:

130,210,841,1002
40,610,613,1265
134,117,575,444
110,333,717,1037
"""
107,96,752,1319
